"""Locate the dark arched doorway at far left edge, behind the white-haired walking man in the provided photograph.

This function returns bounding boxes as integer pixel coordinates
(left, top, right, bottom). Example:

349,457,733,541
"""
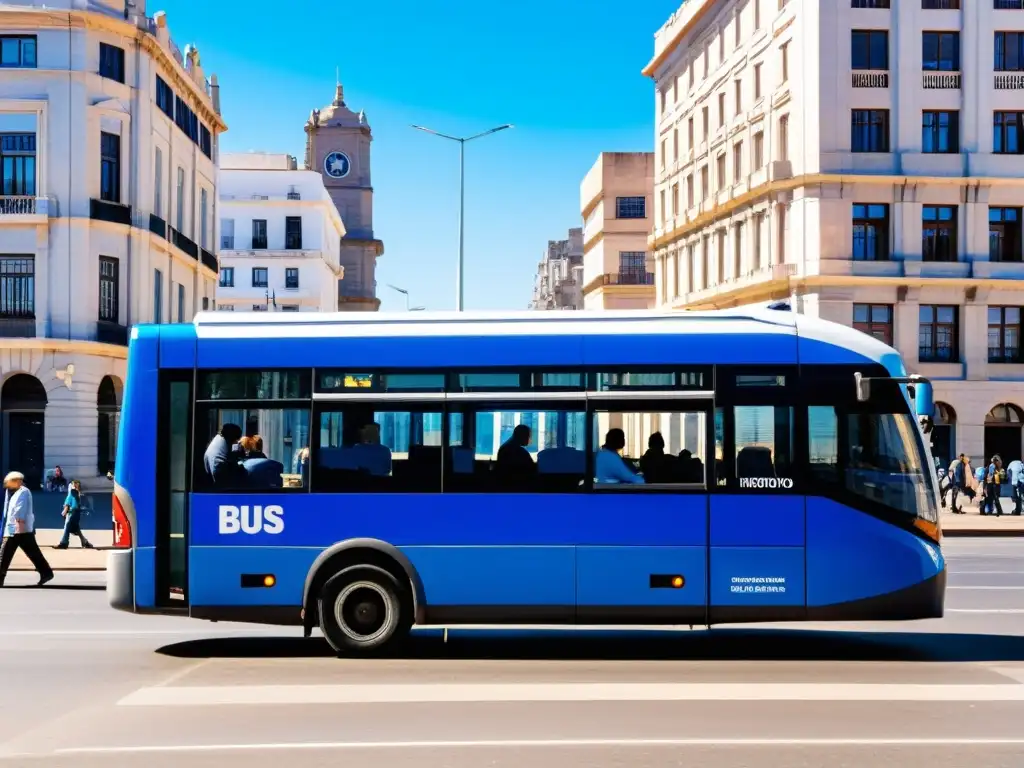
0,374,46,488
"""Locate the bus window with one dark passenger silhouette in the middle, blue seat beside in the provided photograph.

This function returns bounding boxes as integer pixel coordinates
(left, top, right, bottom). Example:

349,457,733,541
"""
444,406,587,494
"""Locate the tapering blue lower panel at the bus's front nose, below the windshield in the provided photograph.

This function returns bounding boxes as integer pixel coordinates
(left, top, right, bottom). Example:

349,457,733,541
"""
807,497,945,607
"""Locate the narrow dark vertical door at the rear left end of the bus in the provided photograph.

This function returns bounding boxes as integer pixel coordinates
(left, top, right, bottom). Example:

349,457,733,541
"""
156,370,193,608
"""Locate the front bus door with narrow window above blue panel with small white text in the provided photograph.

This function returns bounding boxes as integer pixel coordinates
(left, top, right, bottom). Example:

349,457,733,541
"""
709,366,806,624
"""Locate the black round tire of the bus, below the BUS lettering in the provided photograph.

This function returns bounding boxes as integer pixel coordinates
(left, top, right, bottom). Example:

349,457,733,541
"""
317,565,411,655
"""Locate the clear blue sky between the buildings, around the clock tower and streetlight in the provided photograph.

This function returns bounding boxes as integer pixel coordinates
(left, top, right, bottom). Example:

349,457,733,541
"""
155,0,680,309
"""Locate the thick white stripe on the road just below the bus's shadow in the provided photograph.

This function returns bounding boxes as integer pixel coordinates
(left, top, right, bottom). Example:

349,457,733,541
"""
118,683,1024,707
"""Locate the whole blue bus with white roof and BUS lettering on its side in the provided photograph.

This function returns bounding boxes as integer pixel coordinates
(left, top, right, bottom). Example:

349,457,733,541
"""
108,304,946,653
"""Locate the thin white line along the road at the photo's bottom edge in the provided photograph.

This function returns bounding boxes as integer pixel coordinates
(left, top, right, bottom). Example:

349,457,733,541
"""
54,738,1024,760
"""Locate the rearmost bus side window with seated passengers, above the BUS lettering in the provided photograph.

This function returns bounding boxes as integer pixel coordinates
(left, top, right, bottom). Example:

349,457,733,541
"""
196,403,309,493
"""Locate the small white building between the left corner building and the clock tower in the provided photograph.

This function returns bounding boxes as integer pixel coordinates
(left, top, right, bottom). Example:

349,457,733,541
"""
217,153,345,312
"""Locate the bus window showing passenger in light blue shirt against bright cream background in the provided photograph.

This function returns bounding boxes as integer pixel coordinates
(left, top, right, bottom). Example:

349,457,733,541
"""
593,411,708,489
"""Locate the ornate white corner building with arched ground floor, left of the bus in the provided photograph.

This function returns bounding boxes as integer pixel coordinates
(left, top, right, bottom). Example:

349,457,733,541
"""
0,0,225,485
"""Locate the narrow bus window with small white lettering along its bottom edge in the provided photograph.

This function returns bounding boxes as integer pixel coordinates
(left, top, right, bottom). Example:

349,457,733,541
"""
715,406,795,490
